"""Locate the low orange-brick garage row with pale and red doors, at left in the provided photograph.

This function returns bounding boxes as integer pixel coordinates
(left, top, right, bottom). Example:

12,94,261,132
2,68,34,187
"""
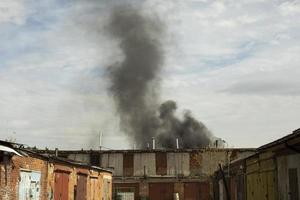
0,141,112,200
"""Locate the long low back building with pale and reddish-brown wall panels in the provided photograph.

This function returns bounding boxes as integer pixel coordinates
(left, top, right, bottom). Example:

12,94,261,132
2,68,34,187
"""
39,148,255,200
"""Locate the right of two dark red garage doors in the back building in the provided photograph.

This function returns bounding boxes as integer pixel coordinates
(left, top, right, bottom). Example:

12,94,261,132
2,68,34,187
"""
184,182,210,200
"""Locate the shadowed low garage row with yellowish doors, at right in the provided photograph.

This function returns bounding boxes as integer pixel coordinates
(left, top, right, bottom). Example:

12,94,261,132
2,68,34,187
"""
214,129,300,200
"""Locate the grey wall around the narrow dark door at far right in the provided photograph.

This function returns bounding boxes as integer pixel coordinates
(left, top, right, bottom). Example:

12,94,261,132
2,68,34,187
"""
276,154,300,200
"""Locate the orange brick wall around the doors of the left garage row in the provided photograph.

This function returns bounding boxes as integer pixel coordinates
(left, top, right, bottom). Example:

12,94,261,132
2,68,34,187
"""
0,156,112,200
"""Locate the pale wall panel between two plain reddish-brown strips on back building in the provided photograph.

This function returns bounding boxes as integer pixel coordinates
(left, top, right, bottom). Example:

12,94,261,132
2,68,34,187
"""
133,153,156,176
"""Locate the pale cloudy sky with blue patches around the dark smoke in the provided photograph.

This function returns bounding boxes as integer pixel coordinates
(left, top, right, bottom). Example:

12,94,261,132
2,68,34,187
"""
0,0,300,149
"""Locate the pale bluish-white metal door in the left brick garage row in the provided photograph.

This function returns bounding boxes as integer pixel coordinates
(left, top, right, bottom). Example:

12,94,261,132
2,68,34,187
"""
19,171,41,200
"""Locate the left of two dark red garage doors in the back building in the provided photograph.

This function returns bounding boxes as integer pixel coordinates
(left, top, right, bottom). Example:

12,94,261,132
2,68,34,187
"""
149,183,174,200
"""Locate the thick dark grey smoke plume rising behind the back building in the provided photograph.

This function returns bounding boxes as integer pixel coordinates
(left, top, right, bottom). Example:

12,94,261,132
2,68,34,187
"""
107,6,211,148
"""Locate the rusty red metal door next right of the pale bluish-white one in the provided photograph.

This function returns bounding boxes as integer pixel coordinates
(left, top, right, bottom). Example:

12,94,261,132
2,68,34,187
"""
54,172,69,200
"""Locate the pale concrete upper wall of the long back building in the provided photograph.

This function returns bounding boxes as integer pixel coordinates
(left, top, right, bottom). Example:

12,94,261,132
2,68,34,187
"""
68,149,254,178
